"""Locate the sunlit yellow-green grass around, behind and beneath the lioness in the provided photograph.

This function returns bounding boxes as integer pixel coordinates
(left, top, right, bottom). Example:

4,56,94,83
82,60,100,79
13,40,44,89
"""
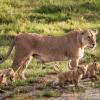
0,0,100,96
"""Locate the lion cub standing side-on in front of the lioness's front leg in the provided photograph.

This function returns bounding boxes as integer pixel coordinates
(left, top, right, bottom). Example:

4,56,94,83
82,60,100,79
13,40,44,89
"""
53,65,87,87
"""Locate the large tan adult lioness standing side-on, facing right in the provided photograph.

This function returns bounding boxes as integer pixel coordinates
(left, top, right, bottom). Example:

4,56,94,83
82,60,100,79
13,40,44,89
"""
1,29,97,79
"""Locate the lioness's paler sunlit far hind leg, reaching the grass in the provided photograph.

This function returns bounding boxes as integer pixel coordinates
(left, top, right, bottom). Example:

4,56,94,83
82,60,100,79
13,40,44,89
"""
18,56,33,80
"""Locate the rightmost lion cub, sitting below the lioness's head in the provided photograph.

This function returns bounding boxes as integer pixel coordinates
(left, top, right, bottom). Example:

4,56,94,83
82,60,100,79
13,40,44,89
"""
82,62,100,81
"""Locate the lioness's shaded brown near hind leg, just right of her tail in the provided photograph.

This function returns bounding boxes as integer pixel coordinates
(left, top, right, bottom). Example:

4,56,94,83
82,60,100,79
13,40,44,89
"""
12,41,32,71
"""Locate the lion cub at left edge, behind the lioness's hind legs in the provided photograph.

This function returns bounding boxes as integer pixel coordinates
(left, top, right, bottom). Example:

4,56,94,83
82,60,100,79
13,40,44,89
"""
0,68,15,84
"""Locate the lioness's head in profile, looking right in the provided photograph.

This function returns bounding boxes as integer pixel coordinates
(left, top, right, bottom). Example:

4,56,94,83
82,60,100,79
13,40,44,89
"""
81,29,97,48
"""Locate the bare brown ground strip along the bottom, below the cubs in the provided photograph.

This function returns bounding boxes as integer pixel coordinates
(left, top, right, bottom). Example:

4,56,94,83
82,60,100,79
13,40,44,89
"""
0,75,100,100
